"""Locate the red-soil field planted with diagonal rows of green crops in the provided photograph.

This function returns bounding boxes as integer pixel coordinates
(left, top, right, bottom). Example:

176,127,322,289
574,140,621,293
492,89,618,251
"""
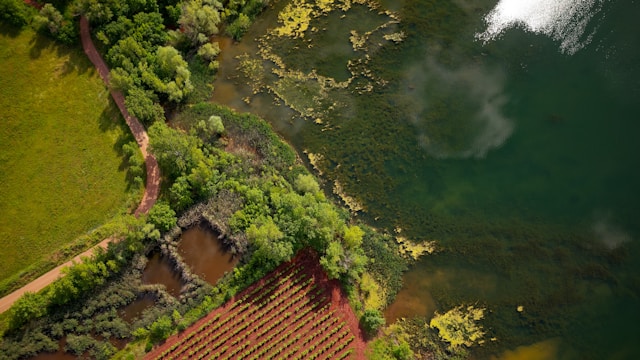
145,251,365,360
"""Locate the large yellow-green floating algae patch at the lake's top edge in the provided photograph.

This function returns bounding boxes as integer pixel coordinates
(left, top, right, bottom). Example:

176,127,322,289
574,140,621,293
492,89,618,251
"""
238,0,404,124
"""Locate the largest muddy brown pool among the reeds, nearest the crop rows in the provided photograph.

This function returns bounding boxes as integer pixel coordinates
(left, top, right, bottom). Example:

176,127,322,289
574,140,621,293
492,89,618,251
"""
178,226,238,285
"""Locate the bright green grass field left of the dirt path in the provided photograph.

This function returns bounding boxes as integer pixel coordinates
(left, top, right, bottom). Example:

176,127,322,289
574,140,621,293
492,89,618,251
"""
0,24,132,282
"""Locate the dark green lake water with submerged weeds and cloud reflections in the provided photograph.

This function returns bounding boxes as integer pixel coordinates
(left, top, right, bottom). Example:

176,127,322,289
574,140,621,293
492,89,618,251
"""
213,0,640,359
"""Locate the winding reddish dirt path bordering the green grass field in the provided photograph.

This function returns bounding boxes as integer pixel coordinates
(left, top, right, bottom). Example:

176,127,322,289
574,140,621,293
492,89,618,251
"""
0,15,160,313
